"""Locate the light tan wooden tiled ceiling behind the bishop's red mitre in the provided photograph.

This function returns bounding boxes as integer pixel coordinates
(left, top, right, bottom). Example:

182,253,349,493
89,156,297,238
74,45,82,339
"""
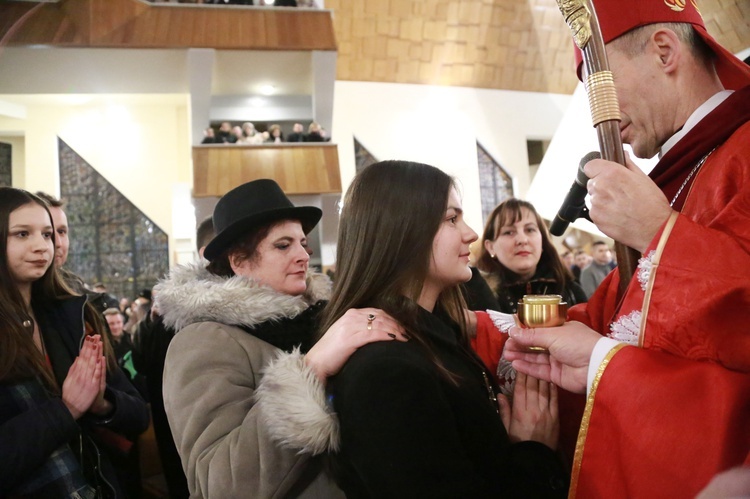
326,0,750,94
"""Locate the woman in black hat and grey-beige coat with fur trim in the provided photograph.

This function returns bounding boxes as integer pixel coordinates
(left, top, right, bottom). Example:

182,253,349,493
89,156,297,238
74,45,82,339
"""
155,179,402,498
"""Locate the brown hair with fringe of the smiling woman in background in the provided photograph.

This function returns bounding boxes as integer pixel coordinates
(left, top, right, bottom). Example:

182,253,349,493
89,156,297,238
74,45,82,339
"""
477,198,573,294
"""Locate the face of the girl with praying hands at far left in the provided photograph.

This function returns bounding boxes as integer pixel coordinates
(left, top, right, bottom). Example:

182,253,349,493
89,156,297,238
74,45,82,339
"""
6,203,55,286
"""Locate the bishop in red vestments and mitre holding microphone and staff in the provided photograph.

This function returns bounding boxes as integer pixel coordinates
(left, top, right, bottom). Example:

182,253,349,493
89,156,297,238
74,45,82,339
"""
505,0,750,498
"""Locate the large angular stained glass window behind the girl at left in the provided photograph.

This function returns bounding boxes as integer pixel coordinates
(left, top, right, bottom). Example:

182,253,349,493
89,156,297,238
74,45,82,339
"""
58,139,169,299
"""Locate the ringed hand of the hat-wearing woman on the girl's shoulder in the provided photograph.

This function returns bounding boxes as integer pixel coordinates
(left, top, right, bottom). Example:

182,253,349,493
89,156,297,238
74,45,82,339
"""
305,308,409,383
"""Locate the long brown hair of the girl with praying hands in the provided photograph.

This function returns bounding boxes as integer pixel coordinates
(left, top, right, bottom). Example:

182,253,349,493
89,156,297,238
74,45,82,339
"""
0,187,116,392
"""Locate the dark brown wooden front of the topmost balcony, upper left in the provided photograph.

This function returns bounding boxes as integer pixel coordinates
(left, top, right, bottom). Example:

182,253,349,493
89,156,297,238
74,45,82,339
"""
0,0,336,50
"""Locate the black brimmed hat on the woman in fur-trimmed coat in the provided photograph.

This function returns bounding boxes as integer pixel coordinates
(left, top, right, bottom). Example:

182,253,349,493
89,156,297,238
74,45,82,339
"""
203,178,323,260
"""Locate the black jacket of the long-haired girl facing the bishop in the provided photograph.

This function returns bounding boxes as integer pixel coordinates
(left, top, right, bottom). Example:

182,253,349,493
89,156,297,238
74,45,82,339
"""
328,310,568,498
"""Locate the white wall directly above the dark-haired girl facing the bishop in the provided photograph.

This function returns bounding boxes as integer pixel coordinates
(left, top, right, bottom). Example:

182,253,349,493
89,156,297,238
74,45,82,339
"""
332,81,571,258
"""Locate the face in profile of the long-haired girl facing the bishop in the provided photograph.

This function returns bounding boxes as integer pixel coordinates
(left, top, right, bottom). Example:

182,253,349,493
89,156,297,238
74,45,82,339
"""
425,188,477,293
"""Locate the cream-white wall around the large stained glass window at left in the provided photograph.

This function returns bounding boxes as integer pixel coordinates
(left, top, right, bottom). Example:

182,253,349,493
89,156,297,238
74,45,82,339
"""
0,94,195,257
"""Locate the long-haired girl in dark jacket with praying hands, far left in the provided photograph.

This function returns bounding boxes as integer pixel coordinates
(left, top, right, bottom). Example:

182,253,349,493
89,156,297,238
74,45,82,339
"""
0,187,148,498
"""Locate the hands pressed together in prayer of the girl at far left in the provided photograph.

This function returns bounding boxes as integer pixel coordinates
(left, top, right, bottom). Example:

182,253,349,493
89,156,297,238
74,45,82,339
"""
62,336,106,419
